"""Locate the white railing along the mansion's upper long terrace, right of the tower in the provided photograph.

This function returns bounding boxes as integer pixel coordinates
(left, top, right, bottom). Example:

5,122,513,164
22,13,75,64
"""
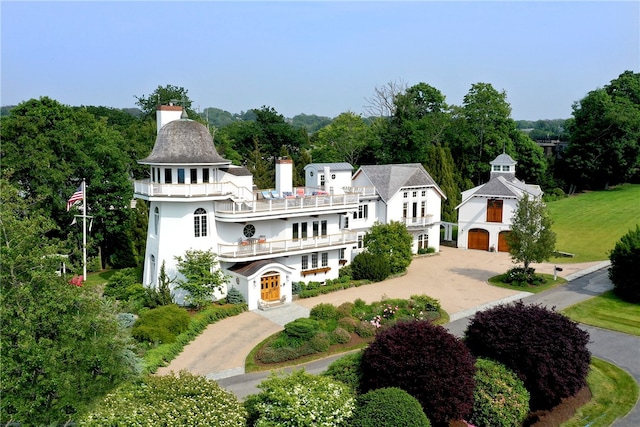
216,194,359,215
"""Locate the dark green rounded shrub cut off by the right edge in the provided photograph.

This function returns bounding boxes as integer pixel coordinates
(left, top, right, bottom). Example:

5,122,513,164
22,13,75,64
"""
609,226,640,304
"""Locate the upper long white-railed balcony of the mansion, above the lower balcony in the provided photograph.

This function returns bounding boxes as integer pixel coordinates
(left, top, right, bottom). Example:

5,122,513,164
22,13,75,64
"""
215,194,360,221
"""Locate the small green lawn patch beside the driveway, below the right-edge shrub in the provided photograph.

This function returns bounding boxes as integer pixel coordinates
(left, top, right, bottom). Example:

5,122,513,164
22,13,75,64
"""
562,291,640,336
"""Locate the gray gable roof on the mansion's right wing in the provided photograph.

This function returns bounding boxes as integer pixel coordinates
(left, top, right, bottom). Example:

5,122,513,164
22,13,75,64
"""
354,163,447,203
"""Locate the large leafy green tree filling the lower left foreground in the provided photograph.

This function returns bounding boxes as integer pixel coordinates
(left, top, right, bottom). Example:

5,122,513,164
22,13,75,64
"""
0,179,140,425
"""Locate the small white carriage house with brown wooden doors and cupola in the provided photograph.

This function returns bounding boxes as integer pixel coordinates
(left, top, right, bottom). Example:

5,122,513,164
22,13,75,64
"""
456,153,542,252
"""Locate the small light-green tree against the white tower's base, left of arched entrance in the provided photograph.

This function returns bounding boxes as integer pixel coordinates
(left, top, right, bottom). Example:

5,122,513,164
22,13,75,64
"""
176,250,226,309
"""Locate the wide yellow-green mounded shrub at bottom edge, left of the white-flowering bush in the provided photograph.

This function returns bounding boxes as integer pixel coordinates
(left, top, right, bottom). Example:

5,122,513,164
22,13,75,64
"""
78,371,247,427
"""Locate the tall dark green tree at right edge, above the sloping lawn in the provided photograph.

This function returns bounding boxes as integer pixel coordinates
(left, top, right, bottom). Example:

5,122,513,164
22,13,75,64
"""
563,71,640,189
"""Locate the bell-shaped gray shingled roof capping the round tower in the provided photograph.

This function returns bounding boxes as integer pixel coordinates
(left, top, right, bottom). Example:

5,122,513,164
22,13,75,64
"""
138,119,231,165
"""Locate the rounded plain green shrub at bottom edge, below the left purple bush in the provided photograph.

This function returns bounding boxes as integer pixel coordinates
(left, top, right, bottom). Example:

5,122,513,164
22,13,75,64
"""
351,387,431,427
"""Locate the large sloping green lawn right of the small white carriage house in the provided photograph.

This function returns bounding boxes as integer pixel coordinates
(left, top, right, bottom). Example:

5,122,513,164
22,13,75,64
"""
547,184,640,263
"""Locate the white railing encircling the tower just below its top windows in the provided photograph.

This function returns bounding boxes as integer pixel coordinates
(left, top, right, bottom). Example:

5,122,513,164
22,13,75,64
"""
133,179,253,200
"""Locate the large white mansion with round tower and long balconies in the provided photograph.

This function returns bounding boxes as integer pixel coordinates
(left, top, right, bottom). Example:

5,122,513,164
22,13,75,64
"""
134,106,444,310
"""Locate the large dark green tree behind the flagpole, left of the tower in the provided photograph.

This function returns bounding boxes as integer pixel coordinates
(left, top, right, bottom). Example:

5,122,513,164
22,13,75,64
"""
0,97,138,266
